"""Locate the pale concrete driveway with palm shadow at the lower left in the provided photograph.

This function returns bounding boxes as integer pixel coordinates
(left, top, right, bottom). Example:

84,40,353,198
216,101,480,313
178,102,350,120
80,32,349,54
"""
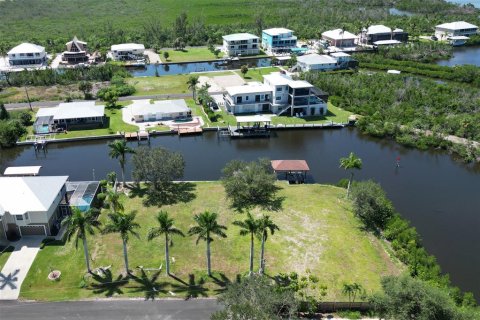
0,236,45,300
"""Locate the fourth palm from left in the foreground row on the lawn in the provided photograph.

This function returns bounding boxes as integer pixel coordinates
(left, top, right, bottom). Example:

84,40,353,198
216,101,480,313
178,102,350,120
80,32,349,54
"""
188,211,227,276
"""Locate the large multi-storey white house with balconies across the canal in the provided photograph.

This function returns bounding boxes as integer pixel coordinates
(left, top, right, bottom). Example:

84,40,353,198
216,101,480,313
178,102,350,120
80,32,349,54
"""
224,72,327,116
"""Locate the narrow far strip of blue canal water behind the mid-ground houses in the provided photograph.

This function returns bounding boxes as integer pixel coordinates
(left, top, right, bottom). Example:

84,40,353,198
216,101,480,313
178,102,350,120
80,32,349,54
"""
128,58,271,77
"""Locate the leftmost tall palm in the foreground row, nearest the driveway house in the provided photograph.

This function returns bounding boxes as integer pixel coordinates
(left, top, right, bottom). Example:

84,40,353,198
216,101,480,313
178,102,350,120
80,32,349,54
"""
62,207,100,273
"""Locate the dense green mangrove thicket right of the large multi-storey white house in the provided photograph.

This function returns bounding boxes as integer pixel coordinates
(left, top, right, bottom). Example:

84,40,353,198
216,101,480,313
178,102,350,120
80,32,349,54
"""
304,73,480,161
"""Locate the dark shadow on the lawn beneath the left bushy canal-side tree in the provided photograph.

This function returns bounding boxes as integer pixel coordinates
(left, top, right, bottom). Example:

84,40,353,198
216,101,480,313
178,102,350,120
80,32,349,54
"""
143,182,196,207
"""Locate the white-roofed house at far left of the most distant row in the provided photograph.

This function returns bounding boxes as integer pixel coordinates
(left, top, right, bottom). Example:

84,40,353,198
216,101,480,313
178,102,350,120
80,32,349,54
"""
7,43,47,67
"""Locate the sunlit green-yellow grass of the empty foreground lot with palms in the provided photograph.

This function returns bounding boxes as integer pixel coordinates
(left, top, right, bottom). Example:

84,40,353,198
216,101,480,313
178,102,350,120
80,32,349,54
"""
21,182,402,300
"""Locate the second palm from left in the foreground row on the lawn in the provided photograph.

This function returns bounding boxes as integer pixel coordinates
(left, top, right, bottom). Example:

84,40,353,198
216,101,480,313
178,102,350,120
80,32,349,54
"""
103,211,140,274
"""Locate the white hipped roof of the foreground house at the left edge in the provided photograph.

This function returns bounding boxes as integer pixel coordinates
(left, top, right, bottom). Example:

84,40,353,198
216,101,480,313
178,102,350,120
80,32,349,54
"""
0,176,68,215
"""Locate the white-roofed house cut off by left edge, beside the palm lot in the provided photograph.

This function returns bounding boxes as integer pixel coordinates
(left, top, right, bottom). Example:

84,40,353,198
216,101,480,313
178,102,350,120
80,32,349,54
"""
0,176,68,238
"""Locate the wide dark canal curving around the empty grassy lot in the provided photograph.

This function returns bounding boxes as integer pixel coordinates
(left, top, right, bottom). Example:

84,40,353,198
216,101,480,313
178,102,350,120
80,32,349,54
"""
0,128,480,298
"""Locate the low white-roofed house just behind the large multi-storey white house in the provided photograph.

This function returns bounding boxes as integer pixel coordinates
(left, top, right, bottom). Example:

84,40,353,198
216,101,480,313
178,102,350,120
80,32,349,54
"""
297,52,356,72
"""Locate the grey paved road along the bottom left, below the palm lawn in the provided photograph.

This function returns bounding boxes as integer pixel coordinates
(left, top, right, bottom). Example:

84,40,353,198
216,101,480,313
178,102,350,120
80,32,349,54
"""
0,299,219,320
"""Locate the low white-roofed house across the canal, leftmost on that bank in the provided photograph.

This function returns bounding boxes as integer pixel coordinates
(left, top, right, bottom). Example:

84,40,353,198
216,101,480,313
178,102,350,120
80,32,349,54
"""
33,101,105,134
